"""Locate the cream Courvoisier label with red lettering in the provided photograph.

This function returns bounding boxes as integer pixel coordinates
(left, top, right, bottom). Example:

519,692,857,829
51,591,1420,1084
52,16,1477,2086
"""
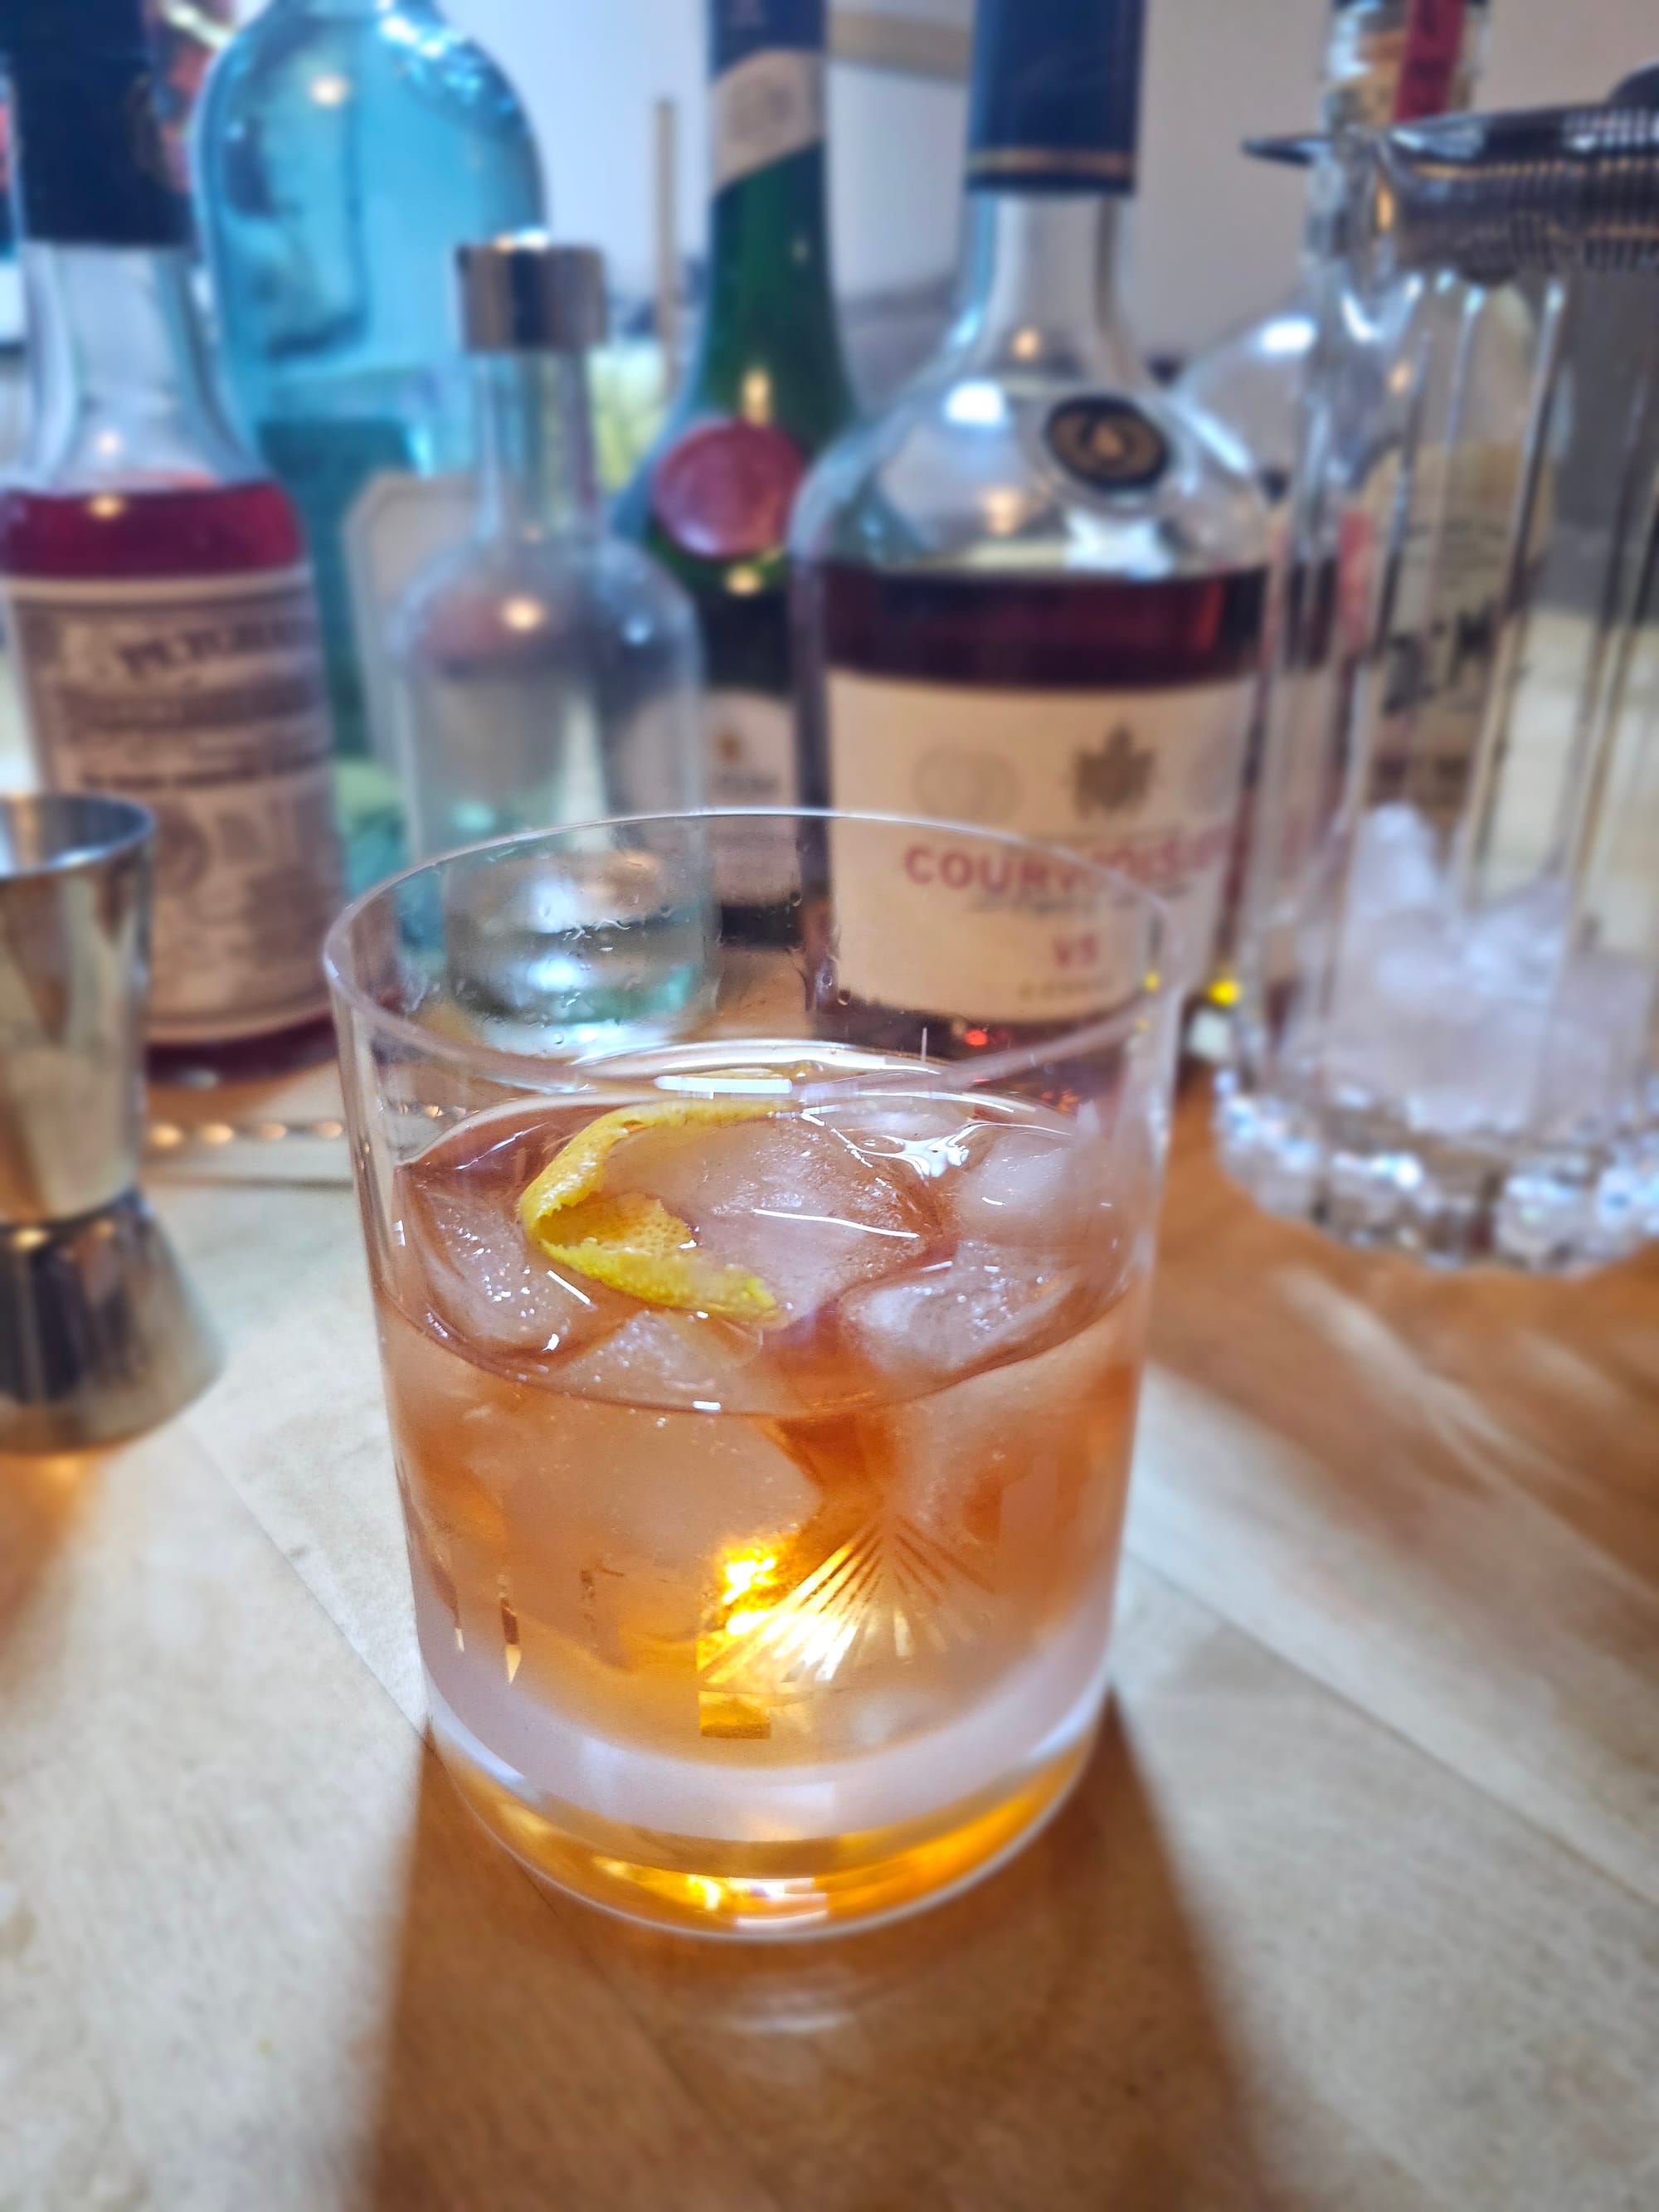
827,668,1257,1022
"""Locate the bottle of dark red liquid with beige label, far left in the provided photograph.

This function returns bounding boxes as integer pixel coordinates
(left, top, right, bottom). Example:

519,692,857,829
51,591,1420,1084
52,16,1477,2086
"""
0,0,338,1068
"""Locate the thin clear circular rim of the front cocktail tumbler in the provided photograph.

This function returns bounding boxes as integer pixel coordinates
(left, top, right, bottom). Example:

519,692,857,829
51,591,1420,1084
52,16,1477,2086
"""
323,807,1181,1104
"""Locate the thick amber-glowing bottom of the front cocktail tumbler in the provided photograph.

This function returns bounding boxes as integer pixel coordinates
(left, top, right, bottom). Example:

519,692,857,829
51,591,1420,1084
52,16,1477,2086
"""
434,1712,1097,1942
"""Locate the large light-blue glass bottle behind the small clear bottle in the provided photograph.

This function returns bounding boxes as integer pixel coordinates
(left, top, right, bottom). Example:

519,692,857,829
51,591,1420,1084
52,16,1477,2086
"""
195,0,542,889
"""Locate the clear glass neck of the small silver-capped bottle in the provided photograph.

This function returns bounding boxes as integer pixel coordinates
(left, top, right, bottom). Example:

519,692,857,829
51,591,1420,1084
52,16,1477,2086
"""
474,354,600,540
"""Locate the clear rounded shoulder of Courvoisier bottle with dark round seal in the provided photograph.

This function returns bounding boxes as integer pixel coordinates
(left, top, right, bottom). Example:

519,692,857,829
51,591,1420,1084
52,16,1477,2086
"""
792,358,1267,581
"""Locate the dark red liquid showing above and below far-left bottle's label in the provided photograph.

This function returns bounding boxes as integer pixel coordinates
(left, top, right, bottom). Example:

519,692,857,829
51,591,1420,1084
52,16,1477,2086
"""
0,480,334,1082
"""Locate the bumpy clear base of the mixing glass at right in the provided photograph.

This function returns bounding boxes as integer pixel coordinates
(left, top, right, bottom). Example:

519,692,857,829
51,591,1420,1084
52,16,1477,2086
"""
1217,1084,1659,1274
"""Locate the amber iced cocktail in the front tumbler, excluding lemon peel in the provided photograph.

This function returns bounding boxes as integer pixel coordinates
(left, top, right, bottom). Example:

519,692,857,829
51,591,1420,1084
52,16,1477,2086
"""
378,1070,1144,1933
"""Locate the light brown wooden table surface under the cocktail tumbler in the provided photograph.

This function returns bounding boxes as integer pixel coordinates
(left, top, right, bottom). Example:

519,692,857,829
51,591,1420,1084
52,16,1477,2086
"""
0,1079,1659,2212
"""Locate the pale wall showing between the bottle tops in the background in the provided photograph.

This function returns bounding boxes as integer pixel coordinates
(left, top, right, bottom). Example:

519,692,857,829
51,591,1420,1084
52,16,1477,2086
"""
246,0,1659,352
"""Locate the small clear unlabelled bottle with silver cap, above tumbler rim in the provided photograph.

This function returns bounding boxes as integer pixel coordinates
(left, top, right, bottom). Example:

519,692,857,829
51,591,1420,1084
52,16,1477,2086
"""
394,232,703,858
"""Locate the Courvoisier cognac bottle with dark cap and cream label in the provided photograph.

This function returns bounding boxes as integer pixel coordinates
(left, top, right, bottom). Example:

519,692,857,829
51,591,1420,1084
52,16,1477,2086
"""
794,0,1267,1051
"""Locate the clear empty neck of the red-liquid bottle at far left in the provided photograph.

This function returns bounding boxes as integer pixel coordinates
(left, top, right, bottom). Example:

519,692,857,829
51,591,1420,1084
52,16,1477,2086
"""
17,239,263,491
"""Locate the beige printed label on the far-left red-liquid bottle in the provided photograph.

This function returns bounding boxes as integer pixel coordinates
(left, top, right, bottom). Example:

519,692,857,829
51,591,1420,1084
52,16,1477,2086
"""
4,568,338,1044
